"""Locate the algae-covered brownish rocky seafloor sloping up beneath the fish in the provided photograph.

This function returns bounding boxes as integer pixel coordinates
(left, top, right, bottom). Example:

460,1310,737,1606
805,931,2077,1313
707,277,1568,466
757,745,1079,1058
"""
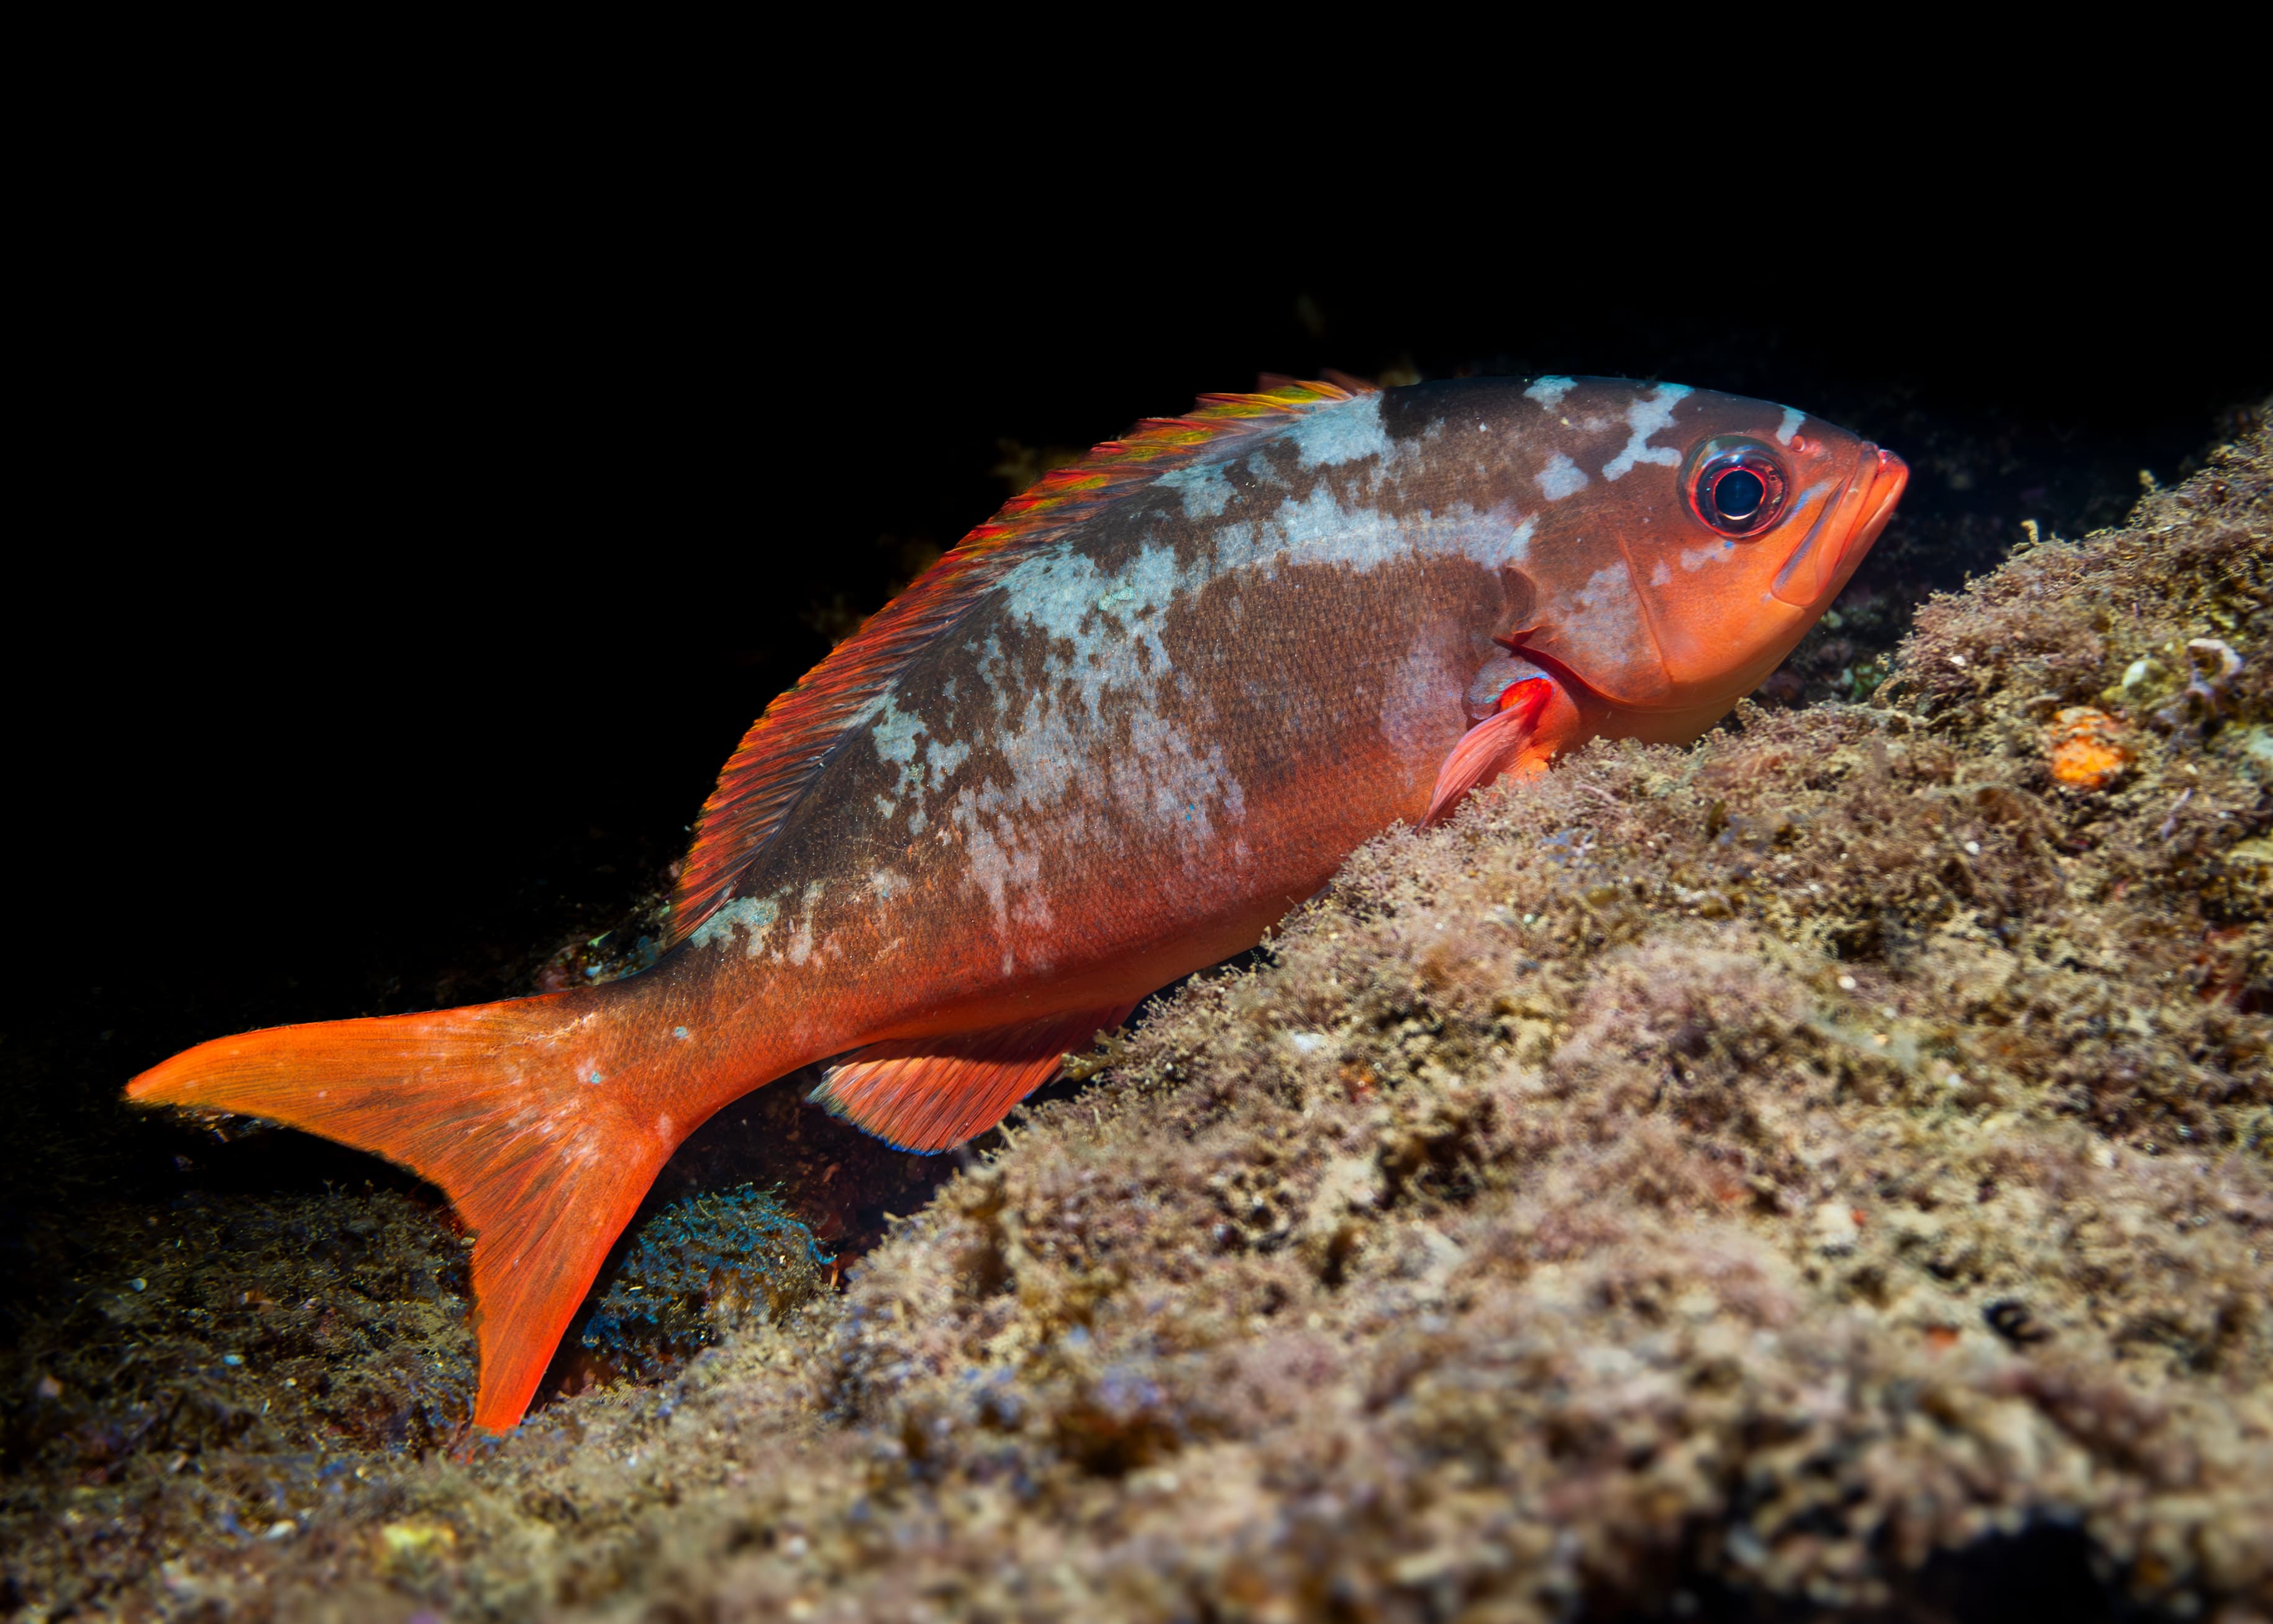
0,398,2273,1624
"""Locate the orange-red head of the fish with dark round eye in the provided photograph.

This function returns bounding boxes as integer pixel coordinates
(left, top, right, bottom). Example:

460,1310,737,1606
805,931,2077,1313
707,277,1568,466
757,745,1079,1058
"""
1500,380,1910,737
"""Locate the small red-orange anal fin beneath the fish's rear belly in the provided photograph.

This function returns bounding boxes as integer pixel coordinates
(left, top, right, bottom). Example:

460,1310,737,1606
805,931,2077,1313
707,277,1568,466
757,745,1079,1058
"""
811,1003,1137,1153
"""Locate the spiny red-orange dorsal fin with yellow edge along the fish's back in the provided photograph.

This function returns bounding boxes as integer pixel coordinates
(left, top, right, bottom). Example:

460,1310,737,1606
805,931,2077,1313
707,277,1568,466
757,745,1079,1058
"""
670,380,1359,942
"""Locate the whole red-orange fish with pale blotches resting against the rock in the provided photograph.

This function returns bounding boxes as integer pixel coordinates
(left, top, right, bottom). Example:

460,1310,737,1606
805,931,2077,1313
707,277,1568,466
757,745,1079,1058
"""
127,378,1907,1428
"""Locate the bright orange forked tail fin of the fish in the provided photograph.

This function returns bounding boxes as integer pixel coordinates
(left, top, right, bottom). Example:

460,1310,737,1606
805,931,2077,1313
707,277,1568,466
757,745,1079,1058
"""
127,992,673,1431
